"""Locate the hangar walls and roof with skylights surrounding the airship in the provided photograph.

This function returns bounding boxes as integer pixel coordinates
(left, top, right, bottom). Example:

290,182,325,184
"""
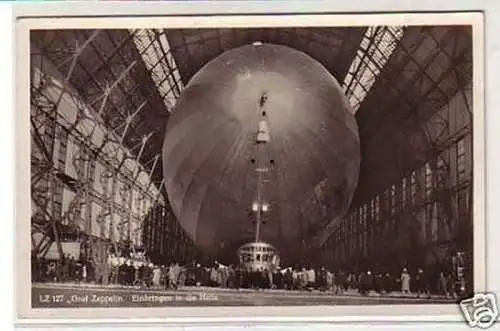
30,26,473,280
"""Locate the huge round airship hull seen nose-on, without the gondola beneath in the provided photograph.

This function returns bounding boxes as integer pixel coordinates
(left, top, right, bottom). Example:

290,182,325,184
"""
162,43,360,264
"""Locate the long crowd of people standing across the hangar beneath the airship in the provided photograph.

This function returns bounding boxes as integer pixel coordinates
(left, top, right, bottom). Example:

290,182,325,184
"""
32,254,465,297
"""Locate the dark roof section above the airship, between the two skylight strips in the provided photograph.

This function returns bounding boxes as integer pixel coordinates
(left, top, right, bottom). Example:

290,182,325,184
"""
165,27,366,84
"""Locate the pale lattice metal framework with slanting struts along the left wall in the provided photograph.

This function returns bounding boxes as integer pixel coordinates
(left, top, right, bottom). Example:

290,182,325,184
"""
31,34,161,258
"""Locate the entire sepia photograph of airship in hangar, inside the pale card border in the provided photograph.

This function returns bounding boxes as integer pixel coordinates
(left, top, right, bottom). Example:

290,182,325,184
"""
17,12,484,320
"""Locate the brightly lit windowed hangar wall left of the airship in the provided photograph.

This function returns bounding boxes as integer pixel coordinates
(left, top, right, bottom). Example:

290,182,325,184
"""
30,45,197,257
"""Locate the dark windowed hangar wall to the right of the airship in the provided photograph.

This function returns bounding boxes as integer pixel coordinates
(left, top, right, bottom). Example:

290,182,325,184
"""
322,85,473,271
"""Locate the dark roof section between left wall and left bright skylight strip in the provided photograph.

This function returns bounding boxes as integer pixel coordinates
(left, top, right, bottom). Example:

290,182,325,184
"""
32,30,172,186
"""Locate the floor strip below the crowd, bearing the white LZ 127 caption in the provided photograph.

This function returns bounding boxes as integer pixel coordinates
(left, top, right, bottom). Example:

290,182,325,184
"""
31,283,455,308
